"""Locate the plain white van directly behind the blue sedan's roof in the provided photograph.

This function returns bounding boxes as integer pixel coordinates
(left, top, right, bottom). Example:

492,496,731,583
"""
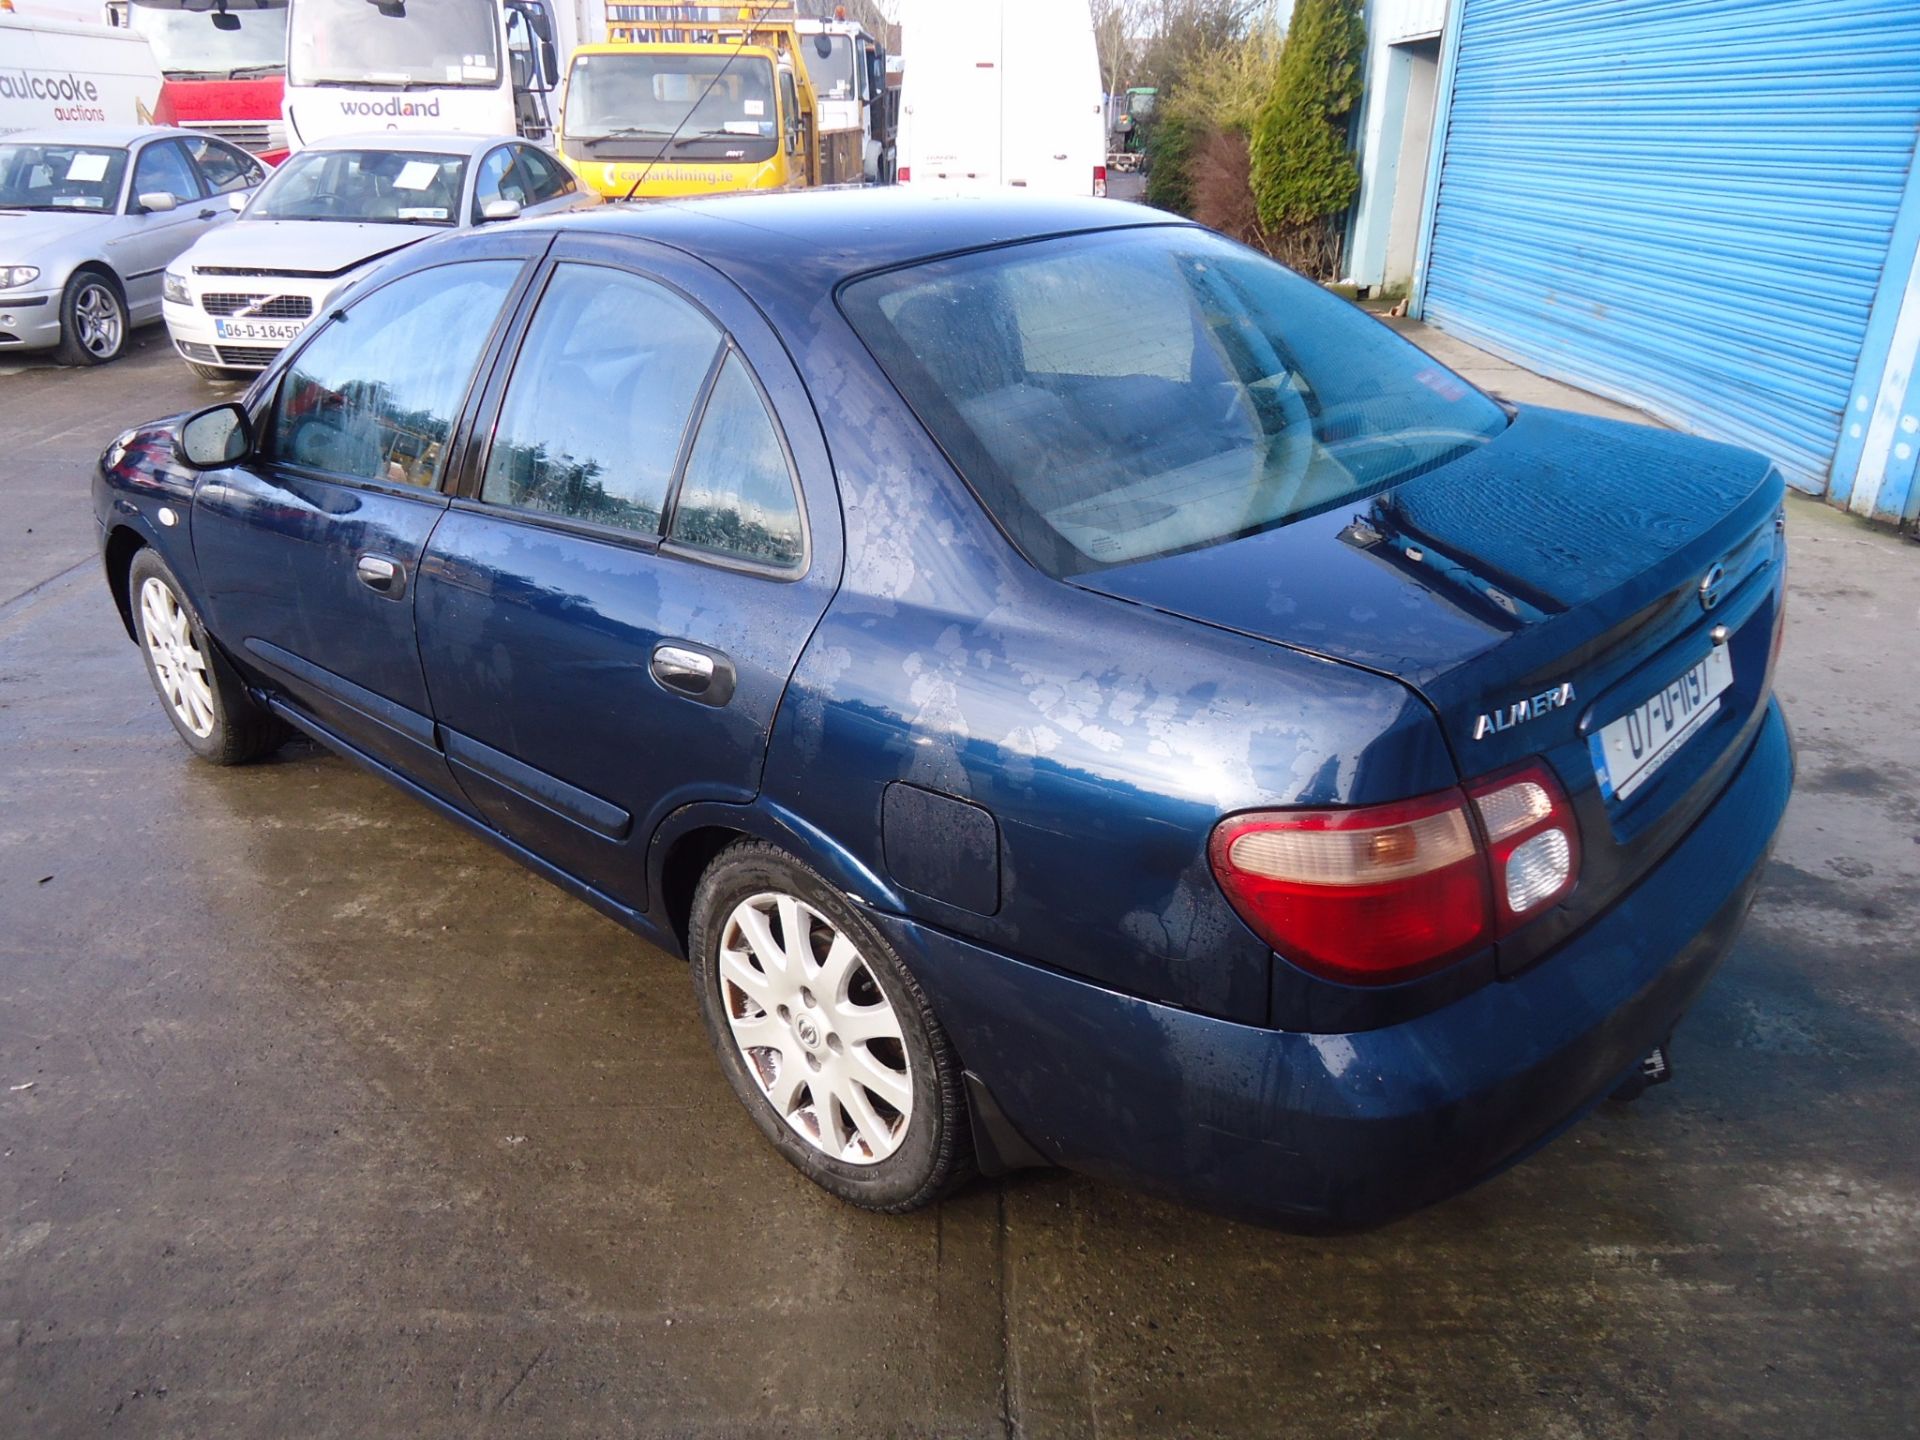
899,0,1106,196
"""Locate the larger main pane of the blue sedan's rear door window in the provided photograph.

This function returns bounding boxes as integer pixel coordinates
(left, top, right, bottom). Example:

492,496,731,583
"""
480,263,722,536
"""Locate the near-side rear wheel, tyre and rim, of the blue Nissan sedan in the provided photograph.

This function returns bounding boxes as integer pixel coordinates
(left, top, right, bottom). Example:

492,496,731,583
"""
689,841,973,1212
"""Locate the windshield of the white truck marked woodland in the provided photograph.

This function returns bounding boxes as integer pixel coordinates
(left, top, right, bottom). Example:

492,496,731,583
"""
288,0,501,88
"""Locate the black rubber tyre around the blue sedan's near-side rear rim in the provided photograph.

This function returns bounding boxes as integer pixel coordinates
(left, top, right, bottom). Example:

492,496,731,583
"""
687,841,975,1213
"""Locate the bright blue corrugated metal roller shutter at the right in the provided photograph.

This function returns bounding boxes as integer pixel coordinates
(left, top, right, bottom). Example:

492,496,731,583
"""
1423,0,1920,492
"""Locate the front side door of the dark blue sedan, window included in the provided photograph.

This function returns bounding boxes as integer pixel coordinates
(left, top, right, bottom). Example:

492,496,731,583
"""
192,236,545,799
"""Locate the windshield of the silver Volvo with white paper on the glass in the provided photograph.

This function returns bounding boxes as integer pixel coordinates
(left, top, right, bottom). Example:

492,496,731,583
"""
242,150,467,225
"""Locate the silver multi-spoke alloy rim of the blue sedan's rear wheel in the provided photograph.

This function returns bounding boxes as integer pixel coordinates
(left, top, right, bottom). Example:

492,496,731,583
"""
718,891,914,1165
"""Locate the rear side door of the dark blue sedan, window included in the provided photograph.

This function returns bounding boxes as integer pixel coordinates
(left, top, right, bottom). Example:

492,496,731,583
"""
417,238,841,908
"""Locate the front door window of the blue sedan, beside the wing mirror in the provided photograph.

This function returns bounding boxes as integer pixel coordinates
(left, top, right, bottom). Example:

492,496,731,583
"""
265,259,520,490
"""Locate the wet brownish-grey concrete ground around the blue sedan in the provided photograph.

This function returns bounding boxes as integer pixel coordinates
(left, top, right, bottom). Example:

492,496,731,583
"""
0,320,1920,1440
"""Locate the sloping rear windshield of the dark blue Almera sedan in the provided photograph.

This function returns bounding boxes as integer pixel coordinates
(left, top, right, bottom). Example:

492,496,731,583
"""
841,227,1507,576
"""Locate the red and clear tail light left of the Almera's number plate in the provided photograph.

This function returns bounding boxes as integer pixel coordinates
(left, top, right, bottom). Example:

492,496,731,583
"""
1208,764,1580,985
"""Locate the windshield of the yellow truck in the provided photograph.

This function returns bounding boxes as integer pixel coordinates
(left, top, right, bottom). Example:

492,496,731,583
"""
566,52,780,146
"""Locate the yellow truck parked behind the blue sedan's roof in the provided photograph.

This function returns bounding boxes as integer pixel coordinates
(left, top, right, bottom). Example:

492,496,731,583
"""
559,0,833,200
